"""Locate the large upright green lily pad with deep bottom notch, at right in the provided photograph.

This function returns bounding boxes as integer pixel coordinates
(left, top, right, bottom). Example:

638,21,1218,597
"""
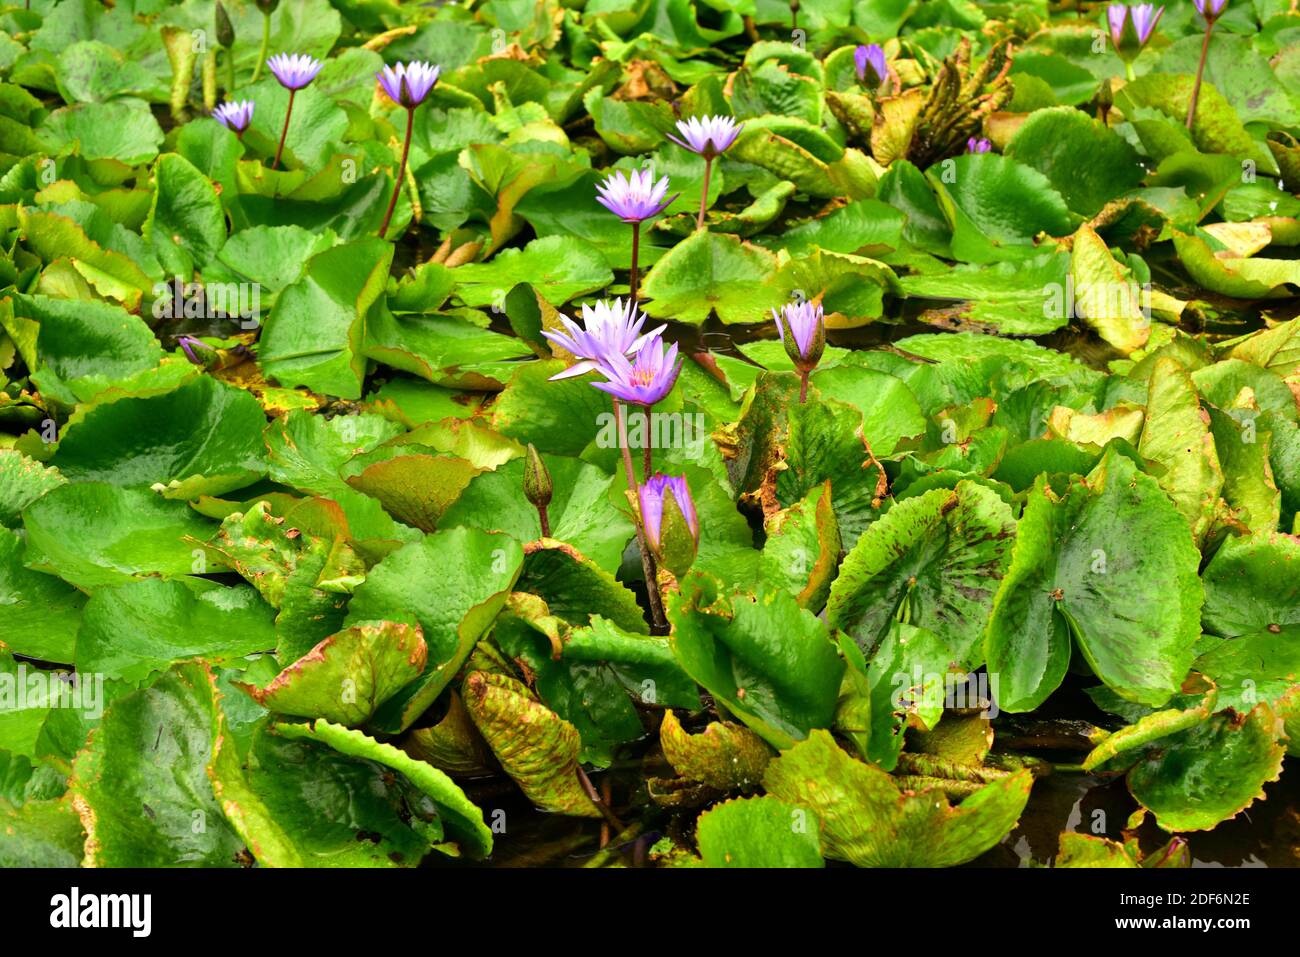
985,450,1203,711
